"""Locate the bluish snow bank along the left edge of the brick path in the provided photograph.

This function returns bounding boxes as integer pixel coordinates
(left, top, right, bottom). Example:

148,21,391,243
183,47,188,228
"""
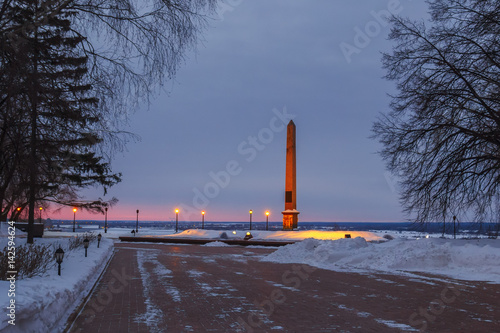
0,237,113,333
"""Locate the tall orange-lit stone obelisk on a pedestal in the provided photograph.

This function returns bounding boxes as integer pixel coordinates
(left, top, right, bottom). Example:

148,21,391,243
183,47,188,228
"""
282,120,299,230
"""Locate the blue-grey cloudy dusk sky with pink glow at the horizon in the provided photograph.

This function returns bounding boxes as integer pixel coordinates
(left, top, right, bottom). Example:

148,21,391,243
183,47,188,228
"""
48,0,427,223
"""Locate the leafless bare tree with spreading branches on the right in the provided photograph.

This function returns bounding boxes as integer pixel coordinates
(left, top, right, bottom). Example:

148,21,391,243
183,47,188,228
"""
373,0,500,222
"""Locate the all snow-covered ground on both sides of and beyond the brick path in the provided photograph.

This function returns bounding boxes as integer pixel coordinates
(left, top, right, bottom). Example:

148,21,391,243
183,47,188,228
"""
0,224,500,333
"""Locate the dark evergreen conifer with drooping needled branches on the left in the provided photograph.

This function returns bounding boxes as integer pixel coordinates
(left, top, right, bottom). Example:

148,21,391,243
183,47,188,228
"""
0,1,120,243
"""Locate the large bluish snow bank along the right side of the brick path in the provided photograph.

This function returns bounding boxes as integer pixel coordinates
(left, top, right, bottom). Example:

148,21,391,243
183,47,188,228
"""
262,237,500,283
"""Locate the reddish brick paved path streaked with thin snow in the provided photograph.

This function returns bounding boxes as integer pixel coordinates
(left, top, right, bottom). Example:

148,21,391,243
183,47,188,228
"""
71,243,500,333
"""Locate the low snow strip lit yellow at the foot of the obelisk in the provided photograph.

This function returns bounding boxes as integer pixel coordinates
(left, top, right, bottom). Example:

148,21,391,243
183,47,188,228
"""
164,229,386,242
